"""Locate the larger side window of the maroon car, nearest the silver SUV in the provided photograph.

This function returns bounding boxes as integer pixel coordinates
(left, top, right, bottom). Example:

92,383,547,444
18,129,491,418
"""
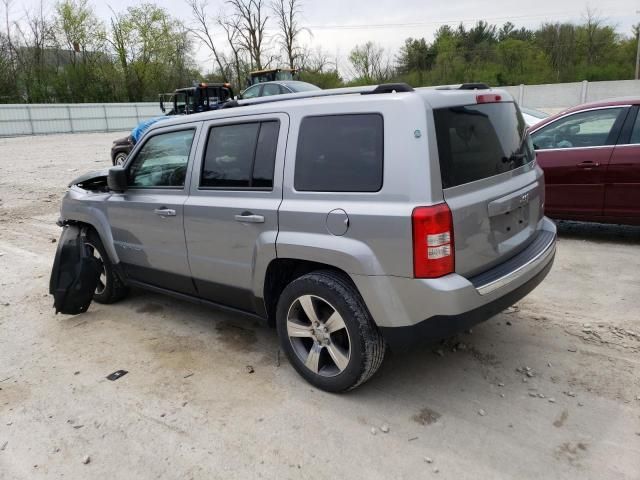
531,108,624,150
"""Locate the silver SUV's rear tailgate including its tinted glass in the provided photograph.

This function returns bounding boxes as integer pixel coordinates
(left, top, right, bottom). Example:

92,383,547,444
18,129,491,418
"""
434,96,543,276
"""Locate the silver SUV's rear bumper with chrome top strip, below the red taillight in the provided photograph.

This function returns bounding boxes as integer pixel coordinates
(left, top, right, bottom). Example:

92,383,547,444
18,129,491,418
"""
352,218,556,347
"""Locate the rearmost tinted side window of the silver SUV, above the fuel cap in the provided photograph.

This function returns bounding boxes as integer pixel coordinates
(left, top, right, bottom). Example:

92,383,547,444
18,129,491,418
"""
294,114,384,192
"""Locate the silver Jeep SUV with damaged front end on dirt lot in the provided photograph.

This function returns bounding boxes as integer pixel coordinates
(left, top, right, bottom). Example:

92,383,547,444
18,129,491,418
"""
52,84,556,392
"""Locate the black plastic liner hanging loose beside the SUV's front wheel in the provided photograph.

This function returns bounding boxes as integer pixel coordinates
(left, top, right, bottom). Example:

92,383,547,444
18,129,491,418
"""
49,225,101,315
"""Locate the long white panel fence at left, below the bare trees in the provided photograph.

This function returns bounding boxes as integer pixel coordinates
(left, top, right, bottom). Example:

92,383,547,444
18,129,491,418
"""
0,103,162,137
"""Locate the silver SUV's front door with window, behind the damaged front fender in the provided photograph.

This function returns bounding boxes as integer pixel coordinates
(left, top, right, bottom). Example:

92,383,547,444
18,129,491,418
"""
107,126,198,295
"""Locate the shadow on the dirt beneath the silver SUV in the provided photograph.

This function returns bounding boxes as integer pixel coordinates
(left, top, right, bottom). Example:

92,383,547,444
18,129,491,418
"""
112,290,519,404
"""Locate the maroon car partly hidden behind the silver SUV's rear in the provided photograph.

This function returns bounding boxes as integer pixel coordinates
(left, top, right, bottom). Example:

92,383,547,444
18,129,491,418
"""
530,98,640,225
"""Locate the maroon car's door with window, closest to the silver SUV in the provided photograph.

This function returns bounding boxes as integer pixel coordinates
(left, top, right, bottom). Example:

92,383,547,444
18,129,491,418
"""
531,107,628,219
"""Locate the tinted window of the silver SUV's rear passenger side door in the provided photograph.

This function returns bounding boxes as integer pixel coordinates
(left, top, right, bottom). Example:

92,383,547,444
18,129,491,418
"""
200,120,280,189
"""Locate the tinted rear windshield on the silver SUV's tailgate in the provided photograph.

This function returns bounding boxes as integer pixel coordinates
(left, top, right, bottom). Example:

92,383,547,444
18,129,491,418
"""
433,102,534,188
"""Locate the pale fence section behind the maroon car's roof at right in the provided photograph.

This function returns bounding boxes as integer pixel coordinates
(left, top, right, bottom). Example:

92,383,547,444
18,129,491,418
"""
504,80,640,113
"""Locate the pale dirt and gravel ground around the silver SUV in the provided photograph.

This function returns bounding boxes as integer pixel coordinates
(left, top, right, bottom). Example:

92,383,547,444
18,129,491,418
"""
0,133,640,480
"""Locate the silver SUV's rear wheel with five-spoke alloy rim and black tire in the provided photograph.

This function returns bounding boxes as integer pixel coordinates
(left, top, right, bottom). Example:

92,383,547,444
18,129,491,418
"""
276,270,385,392
